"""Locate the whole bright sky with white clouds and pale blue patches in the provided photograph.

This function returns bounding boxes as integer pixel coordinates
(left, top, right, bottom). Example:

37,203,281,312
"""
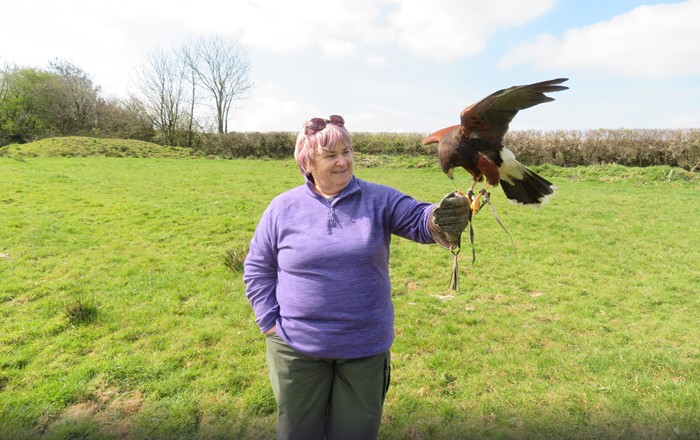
0,0,700,133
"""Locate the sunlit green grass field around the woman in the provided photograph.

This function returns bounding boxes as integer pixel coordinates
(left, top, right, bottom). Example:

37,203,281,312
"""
0,157,700,439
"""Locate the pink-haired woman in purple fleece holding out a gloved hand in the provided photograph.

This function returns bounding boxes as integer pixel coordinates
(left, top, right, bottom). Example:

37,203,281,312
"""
243,115,468,440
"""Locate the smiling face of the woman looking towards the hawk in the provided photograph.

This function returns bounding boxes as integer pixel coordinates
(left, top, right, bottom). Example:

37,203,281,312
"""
311,143,352,196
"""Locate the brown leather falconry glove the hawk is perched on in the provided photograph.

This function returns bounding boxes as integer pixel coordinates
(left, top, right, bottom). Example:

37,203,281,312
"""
428,191,470,250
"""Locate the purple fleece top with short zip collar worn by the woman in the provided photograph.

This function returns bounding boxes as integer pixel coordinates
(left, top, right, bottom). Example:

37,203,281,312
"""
243,177,435,359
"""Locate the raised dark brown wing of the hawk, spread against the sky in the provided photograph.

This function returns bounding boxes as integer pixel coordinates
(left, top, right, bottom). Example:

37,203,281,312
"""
460,78,568,141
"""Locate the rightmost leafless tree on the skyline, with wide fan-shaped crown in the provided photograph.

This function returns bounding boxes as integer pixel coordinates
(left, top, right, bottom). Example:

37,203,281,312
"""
183,35,253,133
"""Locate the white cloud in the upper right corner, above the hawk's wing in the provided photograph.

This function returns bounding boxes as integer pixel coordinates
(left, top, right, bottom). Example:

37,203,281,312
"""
499,0,700,78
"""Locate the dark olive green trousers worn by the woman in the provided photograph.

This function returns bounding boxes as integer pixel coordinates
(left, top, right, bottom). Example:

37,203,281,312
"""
267,335,391,440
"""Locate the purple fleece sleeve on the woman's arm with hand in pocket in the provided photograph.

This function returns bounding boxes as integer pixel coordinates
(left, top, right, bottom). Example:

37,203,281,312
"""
243,207,279,333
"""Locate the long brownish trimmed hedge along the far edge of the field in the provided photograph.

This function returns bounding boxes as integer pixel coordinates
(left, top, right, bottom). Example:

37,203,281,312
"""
194,129,700,170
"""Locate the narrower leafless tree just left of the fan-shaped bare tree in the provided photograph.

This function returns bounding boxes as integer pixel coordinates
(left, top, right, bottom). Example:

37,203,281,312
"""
129,51,187,145
